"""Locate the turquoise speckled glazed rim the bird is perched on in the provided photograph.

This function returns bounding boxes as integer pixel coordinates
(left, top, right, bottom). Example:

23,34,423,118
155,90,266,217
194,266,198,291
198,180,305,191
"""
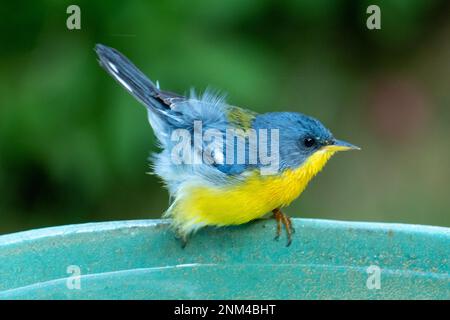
0,219,450,299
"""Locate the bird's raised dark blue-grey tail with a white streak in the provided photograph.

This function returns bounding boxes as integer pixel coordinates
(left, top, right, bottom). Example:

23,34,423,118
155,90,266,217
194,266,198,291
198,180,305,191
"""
95,44,160,108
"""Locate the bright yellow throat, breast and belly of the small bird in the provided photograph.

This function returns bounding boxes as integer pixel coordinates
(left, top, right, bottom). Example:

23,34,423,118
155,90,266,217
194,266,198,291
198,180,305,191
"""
168,150,334,233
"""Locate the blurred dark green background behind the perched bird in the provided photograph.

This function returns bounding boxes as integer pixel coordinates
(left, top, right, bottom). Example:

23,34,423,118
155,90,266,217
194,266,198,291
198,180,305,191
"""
0,0,450,233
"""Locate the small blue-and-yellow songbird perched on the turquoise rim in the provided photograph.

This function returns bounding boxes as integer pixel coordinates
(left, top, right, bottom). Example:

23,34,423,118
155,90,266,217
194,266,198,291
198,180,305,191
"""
95,44,359,245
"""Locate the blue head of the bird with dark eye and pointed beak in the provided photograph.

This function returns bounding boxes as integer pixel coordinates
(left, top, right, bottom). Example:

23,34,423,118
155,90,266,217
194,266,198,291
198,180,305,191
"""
253,112,359,170
